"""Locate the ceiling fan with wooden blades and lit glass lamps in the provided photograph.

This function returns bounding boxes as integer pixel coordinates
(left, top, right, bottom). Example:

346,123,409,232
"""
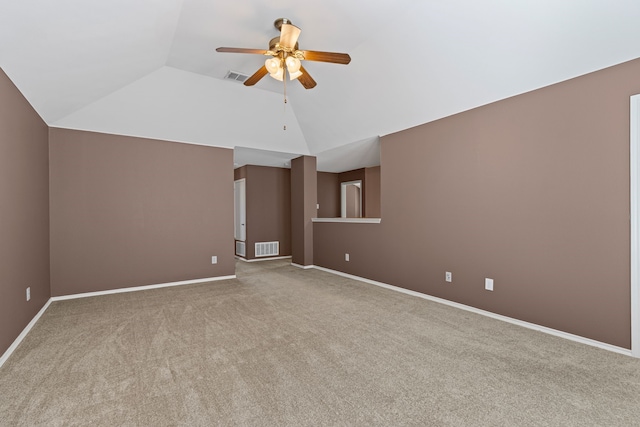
216,18,351,89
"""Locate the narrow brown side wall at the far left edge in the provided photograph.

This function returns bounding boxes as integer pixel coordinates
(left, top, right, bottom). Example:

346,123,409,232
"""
0,69,51,355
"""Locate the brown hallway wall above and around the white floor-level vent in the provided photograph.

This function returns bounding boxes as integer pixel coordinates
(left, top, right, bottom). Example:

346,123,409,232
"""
237,165,291,259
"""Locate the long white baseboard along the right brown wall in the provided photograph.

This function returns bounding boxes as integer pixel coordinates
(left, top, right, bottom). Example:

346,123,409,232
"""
313,266,631,356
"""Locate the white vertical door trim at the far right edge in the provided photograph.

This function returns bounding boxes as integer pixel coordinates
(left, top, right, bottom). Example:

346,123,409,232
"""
629,95,640,358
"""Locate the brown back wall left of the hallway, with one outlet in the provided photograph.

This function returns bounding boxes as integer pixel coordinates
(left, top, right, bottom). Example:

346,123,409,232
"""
50,129,235,295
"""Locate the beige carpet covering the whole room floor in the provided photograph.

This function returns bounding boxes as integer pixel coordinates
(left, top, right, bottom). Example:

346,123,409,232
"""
0,260,640,426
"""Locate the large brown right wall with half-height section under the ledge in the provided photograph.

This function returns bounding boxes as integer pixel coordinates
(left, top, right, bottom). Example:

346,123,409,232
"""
314,60,640,348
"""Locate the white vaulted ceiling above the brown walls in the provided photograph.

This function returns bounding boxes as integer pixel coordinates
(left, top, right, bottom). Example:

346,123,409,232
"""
0,0,640,172
